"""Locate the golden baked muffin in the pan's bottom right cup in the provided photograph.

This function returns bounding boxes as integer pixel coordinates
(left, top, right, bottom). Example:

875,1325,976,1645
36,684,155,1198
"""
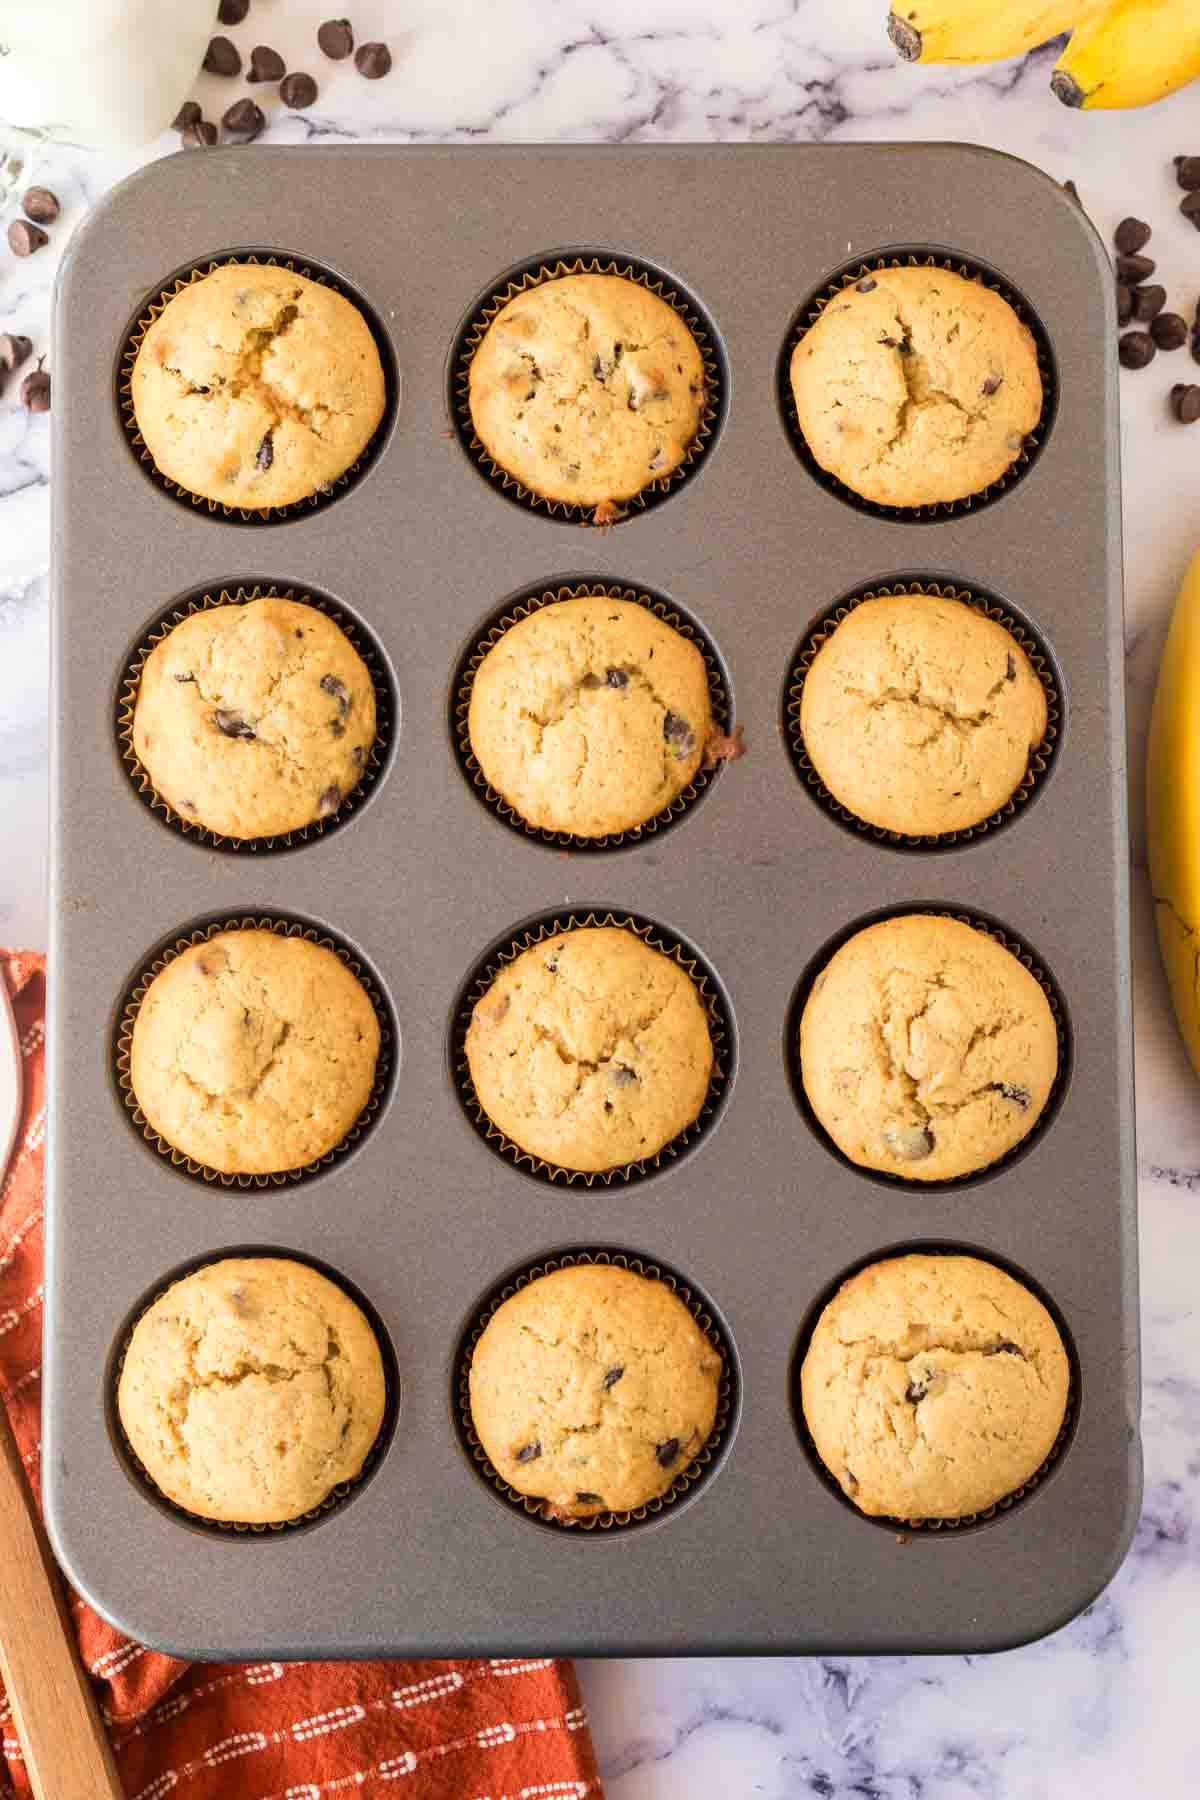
801,1256,1070,1519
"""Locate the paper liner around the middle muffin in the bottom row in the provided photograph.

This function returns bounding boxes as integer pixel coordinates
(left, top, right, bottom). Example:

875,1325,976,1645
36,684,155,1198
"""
453,1249,738,1534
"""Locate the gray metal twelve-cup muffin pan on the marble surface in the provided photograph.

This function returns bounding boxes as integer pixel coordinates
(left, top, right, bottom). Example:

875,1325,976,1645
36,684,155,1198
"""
43,144,1141,1658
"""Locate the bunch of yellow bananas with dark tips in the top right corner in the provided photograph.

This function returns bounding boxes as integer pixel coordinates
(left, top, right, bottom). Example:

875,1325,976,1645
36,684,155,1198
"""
887,0,1200,108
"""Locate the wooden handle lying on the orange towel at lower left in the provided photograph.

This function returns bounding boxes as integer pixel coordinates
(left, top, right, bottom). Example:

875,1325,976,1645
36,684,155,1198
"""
0,1406,124,1800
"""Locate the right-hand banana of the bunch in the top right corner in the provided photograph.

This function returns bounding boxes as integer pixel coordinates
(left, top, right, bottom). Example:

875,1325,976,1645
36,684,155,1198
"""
1051,0,1200,108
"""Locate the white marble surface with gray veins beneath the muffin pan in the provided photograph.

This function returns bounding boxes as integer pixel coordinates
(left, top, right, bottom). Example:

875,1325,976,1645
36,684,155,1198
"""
0,0,1200,1800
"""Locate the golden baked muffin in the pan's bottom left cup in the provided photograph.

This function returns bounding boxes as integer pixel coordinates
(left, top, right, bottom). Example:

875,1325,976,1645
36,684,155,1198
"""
117,1256,385,1525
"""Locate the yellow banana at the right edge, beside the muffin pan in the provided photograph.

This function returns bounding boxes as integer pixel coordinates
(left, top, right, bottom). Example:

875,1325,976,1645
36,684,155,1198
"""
1146,553,1200,1075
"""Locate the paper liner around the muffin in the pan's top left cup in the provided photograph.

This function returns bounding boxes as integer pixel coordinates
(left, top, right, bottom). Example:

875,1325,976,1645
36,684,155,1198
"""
115,250,396,526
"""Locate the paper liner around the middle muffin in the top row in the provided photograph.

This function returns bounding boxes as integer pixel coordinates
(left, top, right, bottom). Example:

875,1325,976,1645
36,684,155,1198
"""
450,252,729,526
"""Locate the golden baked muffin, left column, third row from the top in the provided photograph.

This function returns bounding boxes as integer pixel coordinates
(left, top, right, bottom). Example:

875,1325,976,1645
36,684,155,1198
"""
130,931,380,1175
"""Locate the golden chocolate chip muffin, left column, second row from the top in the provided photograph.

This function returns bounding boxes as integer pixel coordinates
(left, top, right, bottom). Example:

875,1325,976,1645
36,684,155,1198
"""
133,596,376,839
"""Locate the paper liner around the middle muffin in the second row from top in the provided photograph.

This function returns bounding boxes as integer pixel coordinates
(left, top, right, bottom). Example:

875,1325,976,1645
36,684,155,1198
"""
453,581,730,851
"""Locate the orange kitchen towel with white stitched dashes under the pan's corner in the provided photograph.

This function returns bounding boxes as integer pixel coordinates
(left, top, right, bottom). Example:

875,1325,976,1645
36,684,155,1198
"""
0,950,601,1800
